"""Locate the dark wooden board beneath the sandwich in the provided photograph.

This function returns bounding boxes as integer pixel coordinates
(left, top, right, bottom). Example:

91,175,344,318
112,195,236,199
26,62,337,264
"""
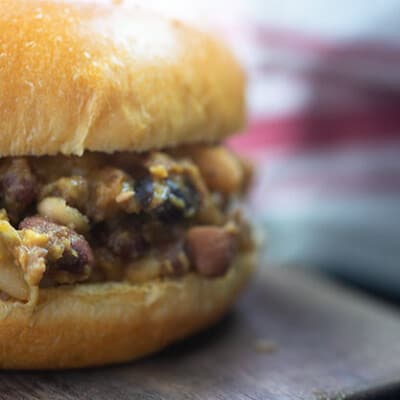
0,268,400,400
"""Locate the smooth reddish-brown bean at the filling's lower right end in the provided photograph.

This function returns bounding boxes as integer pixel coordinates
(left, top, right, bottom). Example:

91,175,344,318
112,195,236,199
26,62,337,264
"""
186,226,236,277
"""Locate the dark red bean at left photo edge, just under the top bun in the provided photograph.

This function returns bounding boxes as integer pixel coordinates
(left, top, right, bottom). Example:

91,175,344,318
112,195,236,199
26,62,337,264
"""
0,158,38,222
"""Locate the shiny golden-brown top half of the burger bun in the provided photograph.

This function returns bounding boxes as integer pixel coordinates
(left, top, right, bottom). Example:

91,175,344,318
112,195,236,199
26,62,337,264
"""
0,0,244,157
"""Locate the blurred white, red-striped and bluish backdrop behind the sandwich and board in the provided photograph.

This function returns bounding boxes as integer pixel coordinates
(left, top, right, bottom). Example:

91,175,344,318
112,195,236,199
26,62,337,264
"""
134,0,400,294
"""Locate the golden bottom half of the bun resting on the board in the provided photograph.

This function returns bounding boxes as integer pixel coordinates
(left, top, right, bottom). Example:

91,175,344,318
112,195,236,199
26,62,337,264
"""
0,253,254,369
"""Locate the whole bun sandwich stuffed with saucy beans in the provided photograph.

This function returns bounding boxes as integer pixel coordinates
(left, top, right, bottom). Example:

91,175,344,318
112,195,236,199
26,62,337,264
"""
0,0,254,369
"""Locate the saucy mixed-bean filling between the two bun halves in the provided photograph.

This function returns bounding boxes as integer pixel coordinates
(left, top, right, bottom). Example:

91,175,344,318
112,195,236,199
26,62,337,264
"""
0,146,252,294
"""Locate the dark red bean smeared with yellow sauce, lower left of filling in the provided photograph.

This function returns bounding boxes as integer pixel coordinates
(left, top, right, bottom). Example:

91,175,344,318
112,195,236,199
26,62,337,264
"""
19,216,93,283
